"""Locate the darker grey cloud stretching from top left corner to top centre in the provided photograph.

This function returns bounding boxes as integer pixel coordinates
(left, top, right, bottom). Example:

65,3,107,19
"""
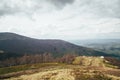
0,0,74,16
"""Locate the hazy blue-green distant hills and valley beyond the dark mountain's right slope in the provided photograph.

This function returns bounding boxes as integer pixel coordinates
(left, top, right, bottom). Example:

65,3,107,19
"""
71,39,120,56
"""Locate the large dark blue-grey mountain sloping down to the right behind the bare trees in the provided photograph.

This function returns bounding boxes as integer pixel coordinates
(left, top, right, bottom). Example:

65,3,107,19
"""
0,33,114,59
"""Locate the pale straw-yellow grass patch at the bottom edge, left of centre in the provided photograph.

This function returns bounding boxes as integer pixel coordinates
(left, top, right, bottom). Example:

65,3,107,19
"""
8,69,75,80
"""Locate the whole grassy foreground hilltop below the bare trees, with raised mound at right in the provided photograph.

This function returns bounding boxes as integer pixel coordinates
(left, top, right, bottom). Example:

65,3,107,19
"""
0,56,120,80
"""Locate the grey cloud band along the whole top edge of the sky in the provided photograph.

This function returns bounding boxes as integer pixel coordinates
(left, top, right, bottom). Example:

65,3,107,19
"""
0,0,120,18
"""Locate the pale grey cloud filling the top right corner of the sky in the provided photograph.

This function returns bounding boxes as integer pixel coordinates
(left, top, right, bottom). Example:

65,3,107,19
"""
79,0,120,18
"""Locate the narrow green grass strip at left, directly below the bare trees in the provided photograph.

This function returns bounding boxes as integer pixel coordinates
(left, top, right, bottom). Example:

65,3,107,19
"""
0,63,64,75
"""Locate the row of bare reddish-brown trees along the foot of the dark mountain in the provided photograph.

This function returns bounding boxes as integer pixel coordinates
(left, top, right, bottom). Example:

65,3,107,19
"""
0,53,77,67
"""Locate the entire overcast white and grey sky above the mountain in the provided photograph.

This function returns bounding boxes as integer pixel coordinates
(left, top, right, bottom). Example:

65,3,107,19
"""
0,0,120,40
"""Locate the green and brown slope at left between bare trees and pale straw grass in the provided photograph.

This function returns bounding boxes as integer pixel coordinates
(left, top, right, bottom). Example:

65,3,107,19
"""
0,63,65,80
